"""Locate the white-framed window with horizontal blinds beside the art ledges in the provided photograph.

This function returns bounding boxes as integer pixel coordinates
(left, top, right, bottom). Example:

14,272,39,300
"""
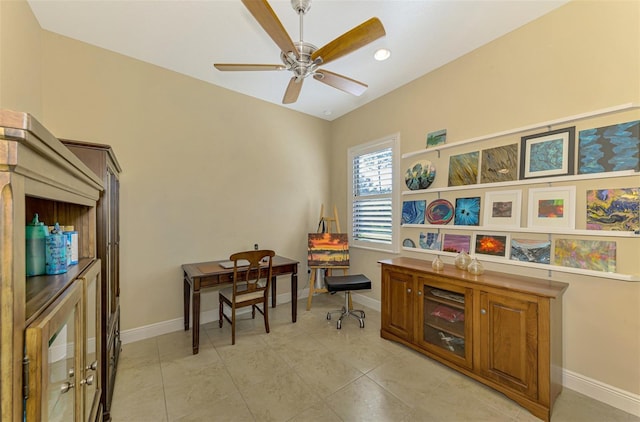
348,135,399,252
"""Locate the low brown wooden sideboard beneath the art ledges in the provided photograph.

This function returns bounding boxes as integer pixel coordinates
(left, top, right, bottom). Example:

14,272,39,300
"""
380,257,568,421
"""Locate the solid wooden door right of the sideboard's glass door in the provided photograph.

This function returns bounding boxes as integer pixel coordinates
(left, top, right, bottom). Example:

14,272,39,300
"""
478,292,538,399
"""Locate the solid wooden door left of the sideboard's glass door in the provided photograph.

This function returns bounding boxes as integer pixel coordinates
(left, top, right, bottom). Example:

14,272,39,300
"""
381,269,415,341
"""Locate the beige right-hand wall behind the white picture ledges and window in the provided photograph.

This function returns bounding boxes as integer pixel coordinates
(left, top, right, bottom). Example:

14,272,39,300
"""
331,1,640,394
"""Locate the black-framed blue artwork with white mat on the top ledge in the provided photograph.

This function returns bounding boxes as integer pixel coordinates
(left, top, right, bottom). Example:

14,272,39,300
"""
520,126,576,179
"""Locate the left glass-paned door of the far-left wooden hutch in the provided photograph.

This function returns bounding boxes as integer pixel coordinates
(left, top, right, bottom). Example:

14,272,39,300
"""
25,283,82,422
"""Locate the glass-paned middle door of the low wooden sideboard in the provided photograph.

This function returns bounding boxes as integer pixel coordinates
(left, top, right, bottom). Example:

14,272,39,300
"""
419,278,472,368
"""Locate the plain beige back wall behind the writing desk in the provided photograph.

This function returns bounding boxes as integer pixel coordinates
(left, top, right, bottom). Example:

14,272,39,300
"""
43,32,329,330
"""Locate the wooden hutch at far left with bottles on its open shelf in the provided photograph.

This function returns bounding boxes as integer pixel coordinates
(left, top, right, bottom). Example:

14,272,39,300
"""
0,110,103,422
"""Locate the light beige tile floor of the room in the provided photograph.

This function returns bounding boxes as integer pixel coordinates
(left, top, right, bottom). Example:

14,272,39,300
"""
111,295,640,422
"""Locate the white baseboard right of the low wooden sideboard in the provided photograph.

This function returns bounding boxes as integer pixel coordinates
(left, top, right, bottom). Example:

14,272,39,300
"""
562,369,640,416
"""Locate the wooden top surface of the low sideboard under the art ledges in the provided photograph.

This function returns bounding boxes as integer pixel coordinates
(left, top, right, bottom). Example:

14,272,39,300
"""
379,257,569,298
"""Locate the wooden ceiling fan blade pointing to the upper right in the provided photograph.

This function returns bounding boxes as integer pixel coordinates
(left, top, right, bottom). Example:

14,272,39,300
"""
311,18,386,64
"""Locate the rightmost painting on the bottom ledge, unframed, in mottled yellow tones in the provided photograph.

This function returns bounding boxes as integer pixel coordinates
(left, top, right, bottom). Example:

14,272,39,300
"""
553,239,616,272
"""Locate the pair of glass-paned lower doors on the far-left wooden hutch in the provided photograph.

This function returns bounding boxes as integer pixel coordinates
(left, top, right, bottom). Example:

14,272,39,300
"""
25,261,102,422
